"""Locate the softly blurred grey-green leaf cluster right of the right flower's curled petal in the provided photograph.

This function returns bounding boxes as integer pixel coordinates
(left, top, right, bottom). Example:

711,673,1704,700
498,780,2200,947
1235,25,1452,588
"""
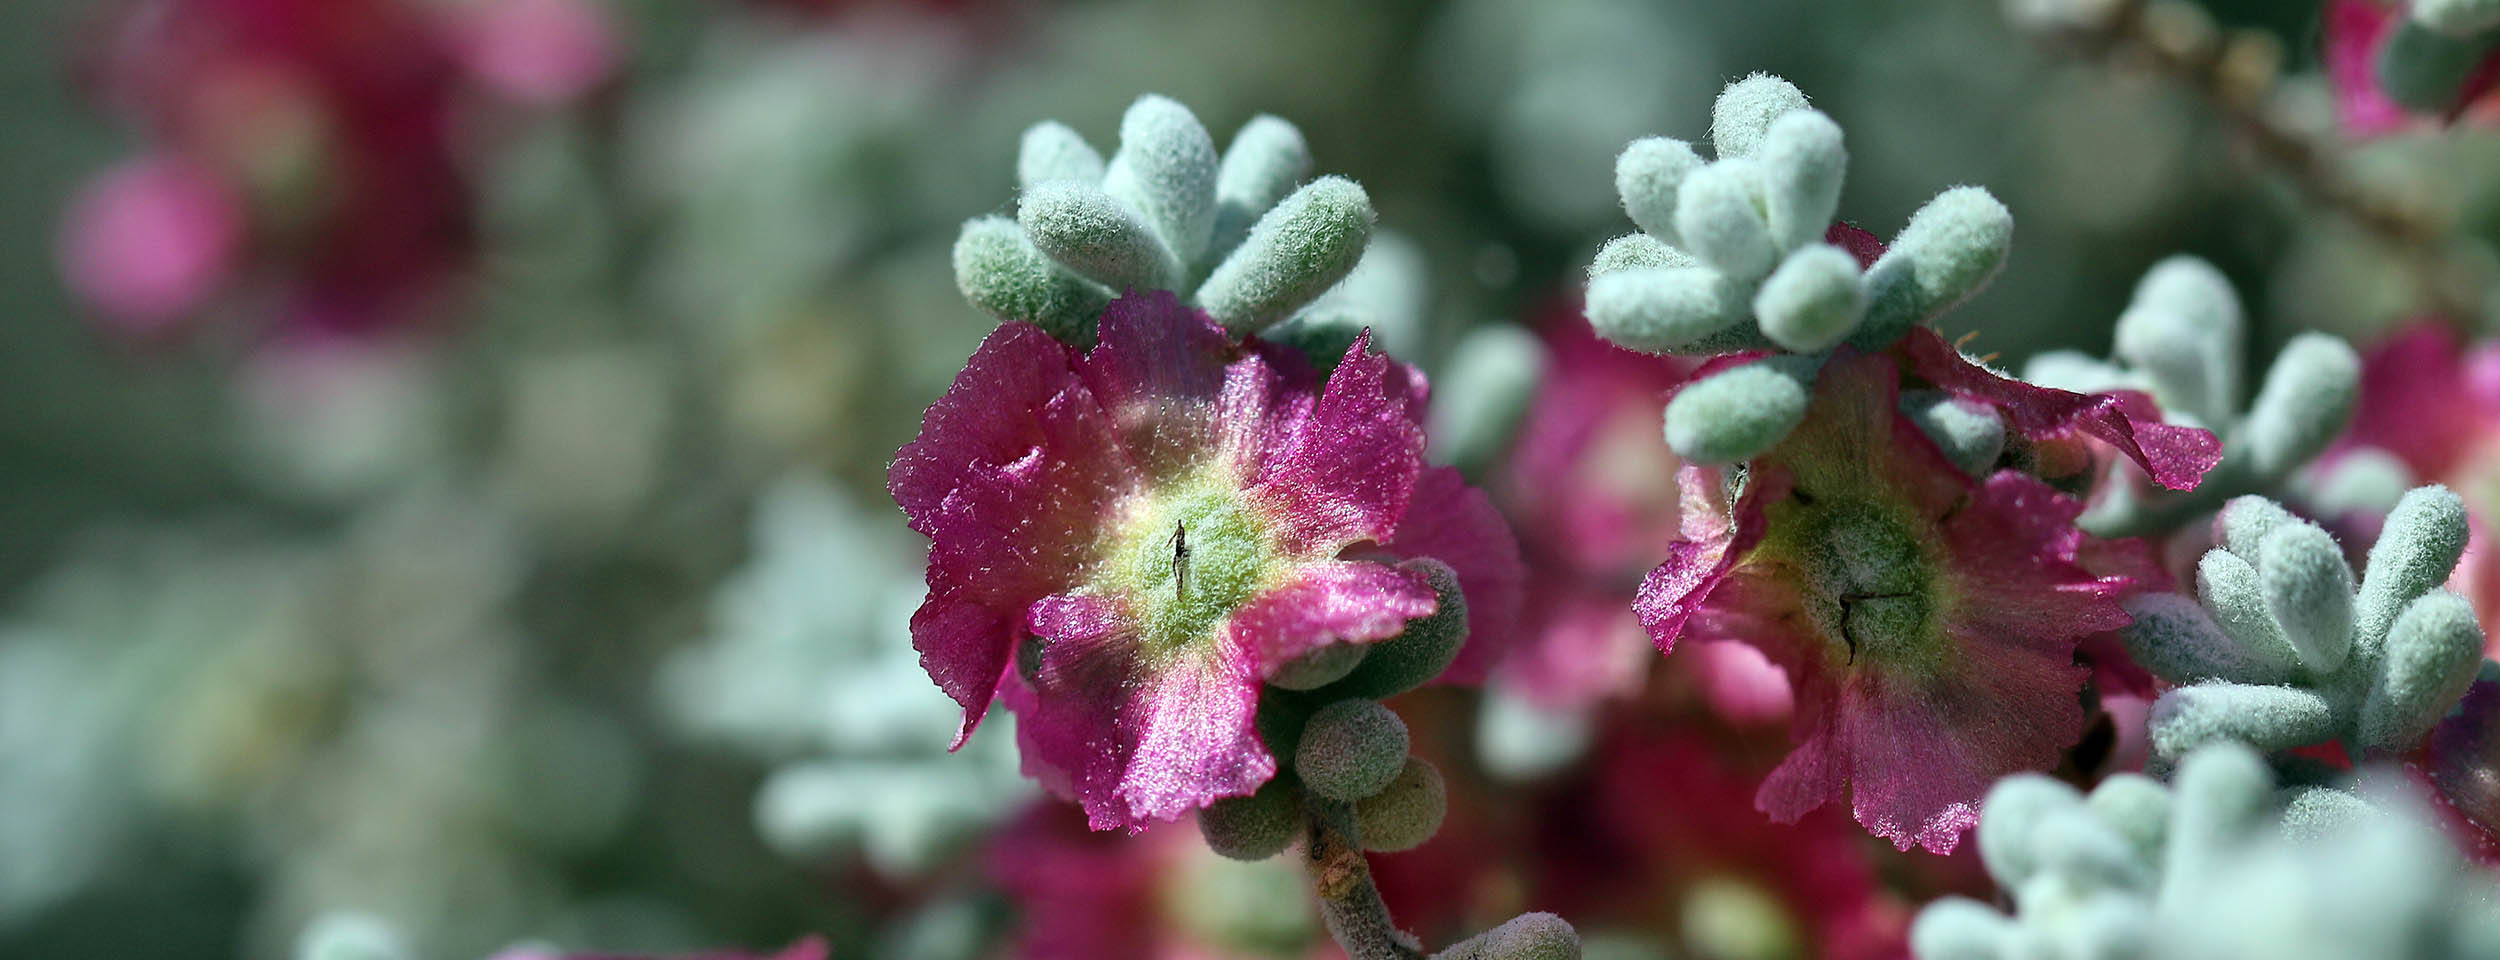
2023,255,2360,538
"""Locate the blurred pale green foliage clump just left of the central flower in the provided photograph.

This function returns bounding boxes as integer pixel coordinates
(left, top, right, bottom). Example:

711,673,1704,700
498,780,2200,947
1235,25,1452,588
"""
658,475,1030,878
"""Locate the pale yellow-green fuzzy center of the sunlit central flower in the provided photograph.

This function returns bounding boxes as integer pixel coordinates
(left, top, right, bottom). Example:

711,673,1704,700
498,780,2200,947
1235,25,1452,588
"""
1100,468,1278,653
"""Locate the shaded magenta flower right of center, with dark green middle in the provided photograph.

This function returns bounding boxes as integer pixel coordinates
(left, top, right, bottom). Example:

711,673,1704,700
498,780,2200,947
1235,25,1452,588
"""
1638,342,2150,853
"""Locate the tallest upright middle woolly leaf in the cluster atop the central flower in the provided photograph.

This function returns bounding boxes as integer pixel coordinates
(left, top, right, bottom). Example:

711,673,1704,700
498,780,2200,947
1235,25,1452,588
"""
1103,93,1215,265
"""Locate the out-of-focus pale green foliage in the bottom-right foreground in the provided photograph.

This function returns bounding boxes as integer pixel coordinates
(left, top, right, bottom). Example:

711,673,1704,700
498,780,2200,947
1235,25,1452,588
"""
1910,745,2500,960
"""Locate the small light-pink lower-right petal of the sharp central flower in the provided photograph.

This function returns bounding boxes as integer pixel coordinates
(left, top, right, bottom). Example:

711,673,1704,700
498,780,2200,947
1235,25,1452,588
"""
1225,560,1438,678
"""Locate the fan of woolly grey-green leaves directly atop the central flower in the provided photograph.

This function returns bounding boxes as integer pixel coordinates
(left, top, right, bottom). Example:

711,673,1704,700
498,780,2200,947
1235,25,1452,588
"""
955,95,1375,345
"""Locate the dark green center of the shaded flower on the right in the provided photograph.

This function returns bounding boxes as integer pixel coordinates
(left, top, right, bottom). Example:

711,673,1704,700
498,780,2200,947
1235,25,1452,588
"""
1760,495,1945,668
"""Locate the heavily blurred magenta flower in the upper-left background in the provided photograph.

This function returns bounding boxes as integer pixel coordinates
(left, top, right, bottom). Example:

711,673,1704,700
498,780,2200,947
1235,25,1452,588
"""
63,0,618,330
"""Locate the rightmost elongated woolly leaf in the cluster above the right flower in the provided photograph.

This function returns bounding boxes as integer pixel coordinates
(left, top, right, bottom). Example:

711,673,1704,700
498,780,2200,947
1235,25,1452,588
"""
1850,188,2015,350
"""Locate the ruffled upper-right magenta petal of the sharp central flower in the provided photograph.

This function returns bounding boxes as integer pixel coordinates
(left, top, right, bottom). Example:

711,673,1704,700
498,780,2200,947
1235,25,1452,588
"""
1253,333,1423,555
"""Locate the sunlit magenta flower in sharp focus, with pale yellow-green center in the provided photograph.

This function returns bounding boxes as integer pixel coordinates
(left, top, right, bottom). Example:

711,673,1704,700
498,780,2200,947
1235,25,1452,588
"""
888,293,1520,830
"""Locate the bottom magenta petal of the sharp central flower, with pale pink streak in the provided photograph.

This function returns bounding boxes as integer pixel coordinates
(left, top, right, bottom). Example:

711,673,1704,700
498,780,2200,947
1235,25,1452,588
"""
1005,593,1270,833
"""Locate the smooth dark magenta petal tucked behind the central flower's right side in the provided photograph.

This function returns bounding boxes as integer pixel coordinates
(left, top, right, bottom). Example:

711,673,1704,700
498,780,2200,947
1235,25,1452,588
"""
1383,468,1528,685
